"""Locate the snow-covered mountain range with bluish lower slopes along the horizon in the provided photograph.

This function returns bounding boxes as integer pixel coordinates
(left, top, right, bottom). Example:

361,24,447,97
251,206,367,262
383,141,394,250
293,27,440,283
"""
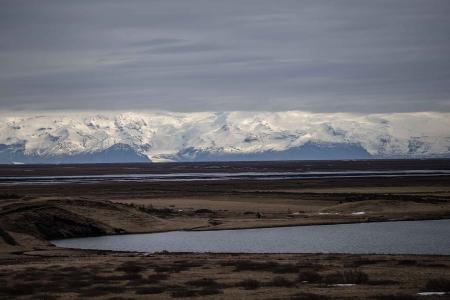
0,111,450,163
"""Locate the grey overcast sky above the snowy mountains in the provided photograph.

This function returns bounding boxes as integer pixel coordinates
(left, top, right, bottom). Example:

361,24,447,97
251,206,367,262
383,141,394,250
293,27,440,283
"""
0,0,450,113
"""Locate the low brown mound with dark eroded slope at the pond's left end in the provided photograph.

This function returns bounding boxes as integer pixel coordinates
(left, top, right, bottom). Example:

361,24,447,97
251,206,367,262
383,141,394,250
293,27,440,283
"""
0,200,159,246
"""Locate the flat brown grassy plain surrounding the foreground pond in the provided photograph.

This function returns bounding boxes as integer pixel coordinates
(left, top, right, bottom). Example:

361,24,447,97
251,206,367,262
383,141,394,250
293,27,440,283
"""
0,161,450,299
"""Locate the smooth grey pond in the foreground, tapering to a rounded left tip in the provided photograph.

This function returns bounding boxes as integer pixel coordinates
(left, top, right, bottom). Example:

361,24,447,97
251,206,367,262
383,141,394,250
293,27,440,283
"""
53,220,450,255
